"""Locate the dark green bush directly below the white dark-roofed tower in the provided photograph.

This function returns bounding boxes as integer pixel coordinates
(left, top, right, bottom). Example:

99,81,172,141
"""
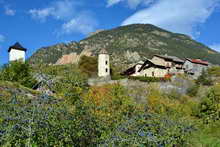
0,61,36,88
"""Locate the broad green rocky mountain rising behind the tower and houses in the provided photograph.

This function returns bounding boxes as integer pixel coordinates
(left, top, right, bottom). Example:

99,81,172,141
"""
29,24,220,65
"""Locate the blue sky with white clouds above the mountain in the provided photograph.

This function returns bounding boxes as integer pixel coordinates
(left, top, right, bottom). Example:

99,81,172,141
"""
0,0,220,64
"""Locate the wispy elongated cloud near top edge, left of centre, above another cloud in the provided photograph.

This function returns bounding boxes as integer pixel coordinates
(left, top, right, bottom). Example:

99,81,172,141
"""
29,0,77,21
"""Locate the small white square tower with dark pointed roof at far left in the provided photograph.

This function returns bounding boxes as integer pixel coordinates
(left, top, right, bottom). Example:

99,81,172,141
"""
8,42,27,62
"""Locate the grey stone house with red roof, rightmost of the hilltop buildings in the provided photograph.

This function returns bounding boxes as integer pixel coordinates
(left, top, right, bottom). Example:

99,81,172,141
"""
183,58,209,79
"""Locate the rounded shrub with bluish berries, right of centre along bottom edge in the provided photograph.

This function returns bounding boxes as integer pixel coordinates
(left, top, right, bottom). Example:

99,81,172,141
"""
103,114,193,147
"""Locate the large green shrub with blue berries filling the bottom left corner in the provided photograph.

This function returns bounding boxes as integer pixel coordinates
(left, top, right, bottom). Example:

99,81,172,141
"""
0,92,106,147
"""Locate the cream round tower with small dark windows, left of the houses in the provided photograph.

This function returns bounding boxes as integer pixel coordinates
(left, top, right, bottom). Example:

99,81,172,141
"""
98,49,110,77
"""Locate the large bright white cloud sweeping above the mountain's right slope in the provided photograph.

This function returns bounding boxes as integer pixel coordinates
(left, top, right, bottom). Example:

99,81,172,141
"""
122,0,220,36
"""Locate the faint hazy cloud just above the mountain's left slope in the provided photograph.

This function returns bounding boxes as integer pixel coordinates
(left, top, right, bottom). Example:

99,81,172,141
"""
62,12,98,35
